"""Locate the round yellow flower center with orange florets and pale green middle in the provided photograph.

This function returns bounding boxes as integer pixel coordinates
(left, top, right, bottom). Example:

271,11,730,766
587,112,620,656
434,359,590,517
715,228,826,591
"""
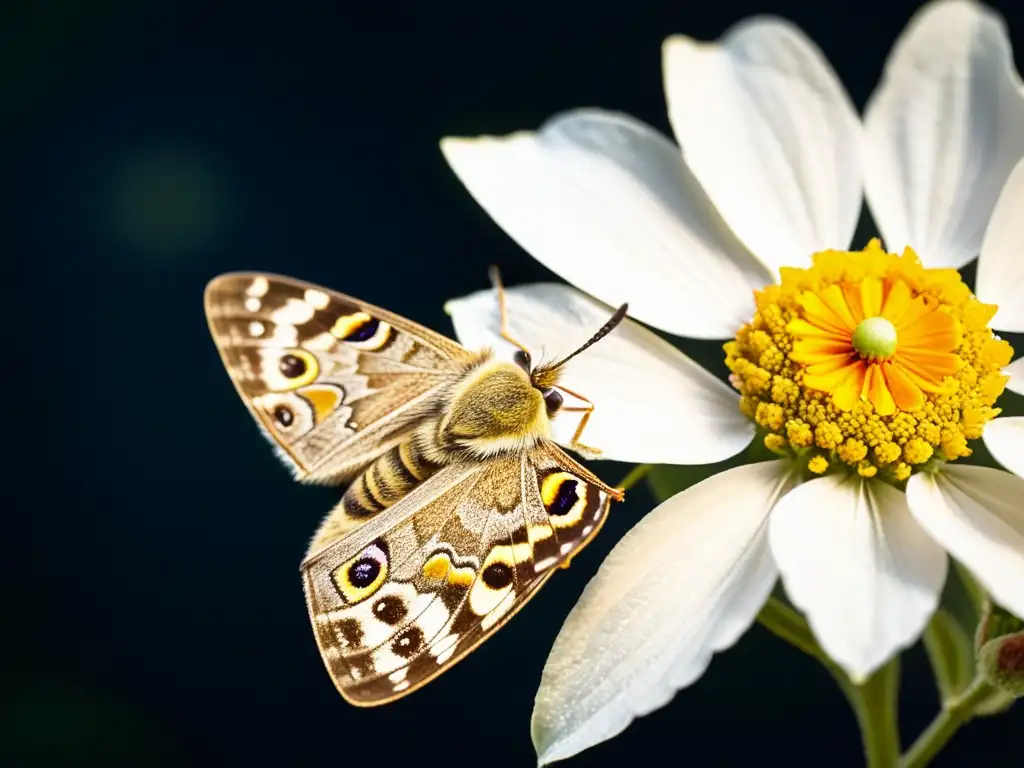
725,240,1013,481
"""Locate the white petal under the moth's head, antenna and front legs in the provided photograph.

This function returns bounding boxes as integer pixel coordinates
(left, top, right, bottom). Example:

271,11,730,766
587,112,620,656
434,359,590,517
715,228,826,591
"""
445,283,754,464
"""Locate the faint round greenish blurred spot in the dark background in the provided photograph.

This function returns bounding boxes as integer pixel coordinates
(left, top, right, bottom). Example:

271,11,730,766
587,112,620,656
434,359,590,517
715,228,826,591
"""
105,150,228,259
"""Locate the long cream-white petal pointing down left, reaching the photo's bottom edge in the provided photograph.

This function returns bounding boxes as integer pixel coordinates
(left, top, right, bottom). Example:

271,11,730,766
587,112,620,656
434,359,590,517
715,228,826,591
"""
531,462,791,765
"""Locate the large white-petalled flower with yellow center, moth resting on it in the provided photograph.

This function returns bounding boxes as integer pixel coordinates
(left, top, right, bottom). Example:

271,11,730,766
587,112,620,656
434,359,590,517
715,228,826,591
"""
441,0,1024,763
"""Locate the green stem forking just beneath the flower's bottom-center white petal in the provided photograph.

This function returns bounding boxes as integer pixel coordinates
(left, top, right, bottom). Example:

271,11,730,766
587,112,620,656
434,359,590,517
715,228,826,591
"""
758,597,900,768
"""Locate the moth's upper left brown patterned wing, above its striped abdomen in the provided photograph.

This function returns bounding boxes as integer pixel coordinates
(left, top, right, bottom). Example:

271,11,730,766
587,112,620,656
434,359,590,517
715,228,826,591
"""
205,273,470,482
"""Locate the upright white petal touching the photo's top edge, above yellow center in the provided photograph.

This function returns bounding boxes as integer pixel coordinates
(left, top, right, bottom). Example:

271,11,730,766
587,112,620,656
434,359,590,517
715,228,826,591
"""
864,0,1024,267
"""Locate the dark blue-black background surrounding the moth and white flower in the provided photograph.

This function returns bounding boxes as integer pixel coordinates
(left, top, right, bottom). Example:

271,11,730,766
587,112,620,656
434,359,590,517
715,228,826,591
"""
0,0,1024,766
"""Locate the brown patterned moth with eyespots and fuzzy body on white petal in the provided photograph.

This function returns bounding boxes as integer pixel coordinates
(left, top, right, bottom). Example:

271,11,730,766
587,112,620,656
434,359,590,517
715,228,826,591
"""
205,270,627,707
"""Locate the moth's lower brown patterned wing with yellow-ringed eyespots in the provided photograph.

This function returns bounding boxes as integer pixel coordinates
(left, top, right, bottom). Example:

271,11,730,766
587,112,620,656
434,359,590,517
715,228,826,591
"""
302,445,609,707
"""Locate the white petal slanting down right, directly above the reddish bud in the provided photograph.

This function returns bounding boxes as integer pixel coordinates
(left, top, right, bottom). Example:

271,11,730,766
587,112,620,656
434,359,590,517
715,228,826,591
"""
906,466,1024,616
